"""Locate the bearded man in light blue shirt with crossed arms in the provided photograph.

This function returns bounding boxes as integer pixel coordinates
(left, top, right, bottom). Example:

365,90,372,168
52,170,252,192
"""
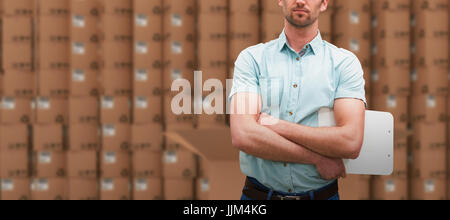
230,0,366,200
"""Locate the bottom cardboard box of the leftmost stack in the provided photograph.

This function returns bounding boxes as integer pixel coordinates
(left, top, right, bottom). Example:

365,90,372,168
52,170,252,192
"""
0,178,31,200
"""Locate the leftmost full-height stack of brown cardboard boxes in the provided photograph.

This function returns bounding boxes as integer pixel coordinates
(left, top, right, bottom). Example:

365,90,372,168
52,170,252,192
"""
0,0,36,200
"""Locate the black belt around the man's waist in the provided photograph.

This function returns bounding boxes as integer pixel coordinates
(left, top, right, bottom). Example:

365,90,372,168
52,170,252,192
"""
243,178,339,200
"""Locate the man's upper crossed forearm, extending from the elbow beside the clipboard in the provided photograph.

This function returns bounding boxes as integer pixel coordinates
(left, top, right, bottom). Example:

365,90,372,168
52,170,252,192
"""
268,120,355,159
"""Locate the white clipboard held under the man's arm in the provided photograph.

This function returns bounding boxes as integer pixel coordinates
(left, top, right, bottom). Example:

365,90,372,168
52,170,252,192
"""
319,108,394,176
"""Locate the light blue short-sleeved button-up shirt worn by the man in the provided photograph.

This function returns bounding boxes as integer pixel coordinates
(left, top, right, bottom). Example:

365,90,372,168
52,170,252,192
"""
230,31,366,193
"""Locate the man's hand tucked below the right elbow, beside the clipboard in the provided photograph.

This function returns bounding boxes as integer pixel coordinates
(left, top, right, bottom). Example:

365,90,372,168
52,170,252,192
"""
316,157,347,180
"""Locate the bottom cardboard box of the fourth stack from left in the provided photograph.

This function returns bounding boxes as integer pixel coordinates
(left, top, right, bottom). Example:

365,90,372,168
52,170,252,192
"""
100,178,131,200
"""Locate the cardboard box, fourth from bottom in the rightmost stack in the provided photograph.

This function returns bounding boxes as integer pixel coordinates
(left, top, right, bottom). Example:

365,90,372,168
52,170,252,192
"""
411,95,447,123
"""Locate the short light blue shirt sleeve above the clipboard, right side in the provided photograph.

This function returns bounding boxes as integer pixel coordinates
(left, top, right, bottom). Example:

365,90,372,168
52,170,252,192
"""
335,56,367,108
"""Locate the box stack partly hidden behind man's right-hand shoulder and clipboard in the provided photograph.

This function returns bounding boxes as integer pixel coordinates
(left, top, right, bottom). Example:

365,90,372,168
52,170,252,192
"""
332,0,371,199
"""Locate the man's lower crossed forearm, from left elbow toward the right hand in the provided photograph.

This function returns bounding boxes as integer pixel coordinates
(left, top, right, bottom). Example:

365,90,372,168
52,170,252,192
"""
232,118,324,165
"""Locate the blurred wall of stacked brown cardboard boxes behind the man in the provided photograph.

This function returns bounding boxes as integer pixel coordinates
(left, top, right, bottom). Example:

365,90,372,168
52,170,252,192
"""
0,0,450,200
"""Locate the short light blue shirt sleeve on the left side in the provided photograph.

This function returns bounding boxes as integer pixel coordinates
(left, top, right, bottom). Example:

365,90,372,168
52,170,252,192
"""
229,49,261,100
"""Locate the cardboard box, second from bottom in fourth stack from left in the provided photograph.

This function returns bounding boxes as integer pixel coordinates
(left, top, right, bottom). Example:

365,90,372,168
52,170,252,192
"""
100,150,131,178
